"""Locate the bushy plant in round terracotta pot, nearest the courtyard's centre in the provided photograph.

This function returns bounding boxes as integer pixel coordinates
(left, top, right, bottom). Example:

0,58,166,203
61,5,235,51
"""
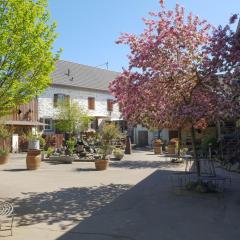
95,123,121,170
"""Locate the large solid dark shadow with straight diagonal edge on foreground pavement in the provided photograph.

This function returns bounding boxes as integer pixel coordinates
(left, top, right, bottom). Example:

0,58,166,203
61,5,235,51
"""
54,170,240,240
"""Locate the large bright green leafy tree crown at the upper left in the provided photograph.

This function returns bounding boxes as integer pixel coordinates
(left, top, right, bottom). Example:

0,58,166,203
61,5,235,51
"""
0,0,59,115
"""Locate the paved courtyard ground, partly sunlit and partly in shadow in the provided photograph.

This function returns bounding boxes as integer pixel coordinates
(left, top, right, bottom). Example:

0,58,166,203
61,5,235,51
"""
0,151,240,240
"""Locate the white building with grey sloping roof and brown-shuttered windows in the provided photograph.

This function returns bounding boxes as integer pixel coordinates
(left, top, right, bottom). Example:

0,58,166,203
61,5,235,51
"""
38,60,122,133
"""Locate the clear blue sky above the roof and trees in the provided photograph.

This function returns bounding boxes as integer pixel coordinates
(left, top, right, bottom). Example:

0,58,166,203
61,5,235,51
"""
49,0,240,71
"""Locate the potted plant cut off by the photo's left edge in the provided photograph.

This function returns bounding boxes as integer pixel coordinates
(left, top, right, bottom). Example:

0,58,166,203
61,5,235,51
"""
0,125,11,164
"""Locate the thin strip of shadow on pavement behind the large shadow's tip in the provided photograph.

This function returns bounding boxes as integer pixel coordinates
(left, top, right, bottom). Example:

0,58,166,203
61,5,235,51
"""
109,160,178,169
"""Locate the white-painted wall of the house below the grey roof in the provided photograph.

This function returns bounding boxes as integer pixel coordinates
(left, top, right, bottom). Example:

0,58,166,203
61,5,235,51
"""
38,87,121,130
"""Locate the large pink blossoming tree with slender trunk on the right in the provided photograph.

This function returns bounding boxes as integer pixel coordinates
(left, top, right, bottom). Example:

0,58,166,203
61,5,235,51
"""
110,1,240,175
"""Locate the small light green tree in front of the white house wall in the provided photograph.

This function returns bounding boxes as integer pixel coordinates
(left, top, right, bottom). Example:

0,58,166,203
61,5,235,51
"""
55,102,91,135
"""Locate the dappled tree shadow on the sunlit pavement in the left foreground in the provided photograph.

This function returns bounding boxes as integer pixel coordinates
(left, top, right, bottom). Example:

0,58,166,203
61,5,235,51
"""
11,184,131,229
